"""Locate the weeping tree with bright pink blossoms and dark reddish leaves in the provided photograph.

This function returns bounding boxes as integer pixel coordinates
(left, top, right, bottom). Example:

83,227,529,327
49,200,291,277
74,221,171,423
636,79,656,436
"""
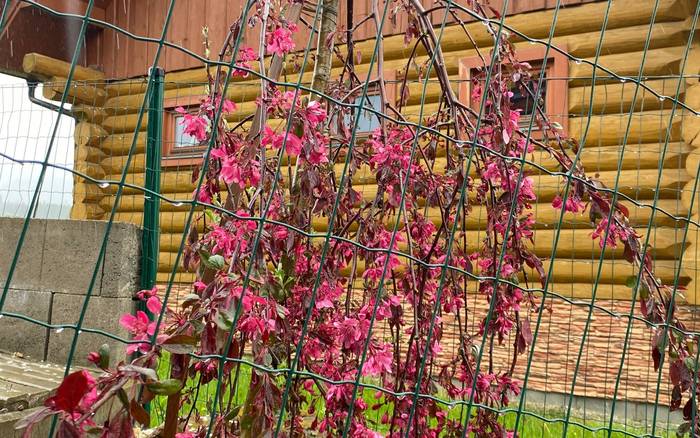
19,0,698,437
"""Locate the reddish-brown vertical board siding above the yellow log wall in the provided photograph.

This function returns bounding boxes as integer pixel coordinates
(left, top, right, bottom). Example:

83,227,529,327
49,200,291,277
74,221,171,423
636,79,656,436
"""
95,0,597,78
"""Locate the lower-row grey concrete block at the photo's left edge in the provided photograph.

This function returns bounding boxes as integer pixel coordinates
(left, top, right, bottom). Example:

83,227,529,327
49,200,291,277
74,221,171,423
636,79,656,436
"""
0,289,51,360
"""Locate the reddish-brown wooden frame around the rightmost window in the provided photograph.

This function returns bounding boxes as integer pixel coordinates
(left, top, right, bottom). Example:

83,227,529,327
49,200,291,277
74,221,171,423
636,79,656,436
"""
459,45,569,139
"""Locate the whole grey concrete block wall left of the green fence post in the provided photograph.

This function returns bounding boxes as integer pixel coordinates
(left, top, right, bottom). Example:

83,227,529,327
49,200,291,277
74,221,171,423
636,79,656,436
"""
0,218,141,364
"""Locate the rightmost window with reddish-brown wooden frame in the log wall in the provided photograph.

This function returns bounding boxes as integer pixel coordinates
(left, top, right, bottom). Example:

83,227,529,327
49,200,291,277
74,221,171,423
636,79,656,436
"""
459,47,569,138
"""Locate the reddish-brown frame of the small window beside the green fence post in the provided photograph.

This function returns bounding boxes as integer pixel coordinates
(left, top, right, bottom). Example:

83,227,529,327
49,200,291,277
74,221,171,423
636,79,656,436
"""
161,95,207,167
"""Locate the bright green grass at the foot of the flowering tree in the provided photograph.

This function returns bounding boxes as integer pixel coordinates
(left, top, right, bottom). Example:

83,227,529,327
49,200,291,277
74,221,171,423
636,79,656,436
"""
151,352,675,438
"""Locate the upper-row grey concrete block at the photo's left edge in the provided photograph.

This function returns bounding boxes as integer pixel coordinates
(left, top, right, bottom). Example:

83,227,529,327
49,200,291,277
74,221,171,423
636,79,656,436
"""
0,218,48,290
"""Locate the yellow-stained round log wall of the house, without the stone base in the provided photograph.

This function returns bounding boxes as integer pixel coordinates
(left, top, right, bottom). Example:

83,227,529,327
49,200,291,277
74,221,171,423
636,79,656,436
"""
86,0,697,297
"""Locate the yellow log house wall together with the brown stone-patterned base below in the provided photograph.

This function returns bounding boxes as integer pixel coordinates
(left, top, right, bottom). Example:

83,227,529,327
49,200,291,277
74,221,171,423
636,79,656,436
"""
21,0,700,412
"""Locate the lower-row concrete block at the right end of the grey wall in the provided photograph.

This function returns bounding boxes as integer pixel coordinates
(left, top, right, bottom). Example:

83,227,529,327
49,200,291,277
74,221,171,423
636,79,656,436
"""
46,294,135,365
